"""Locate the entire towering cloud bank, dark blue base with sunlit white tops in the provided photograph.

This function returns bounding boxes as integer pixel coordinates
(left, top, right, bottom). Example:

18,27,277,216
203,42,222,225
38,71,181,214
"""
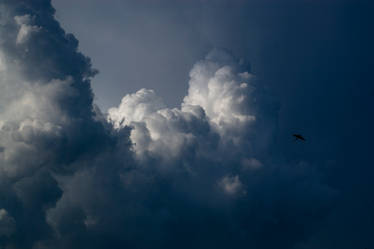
0,0,335,249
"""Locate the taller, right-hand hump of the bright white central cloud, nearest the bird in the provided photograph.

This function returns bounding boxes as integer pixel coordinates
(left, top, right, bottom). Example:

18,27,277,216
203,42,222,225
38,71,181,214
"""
182,50,256,136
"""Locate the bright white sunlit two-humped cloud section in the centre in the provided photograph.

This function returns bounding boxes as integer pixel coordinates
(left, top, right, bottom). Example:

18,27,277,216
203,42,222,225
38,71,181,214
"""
109,50,256,160
